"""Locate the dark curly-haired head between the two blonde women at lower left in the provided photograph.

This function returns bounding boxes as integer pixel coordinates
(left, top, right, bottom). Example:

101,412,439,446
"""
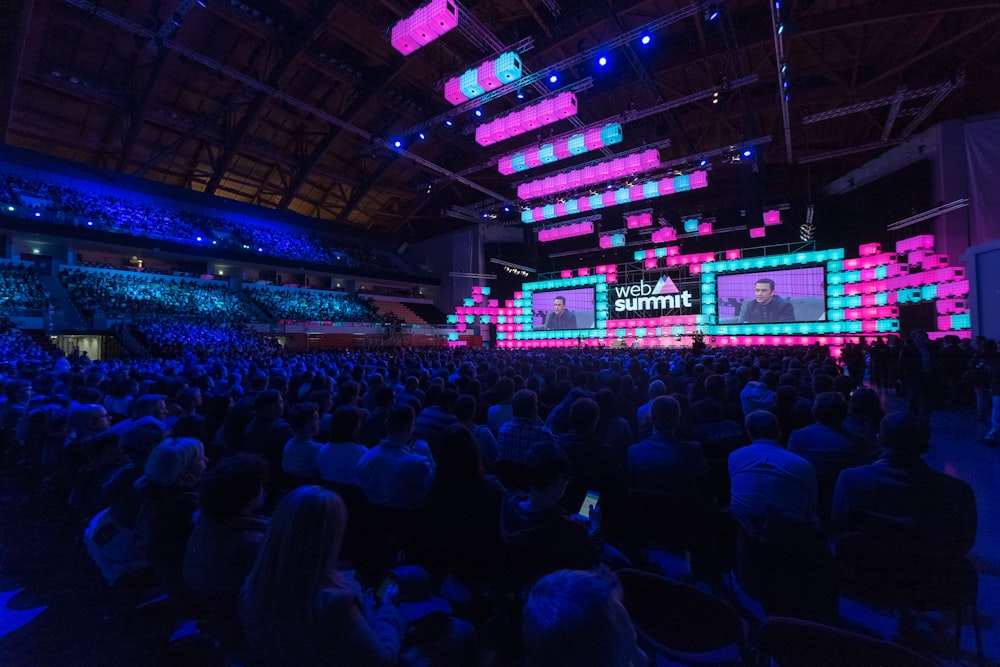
198,452,268,517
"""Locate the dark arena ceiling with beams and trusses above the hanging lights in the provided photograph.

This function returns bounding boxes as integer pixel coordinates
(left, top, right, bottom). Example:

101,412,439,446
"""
0,0,1000,240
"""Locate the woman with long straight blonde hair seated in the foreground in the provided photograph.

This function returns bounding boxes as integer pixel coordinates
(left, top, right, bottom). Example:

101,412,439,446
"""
240,486,406,667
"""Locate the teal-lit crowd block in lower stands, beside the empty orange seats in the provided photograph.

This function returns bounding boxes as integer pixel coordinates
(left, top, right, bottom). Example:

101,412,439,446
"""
243,287,383,322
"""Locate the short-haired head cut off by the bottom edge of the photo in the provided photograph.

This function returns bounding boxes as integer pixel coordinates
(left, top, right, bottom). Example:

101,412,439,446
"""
522,570,648,667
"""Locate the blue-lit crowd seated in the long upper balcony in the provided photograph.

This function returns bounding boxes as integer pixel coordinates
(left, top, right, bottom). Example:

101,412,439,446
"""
0,175,399,271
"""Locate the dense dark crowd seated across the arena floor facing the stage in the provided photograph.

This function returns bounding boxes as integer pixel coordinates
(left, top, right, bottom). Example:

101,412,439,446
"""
0,336,984,665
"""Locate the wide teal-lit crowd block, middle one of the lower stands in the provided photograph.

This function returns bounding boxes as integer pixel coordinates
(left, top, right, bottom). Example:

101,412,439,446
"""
59,268,256,322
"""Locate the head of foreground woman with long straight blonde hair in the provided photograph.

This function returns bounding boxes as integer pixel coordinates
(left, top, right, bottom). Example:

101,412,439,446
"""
242,486,347,616
